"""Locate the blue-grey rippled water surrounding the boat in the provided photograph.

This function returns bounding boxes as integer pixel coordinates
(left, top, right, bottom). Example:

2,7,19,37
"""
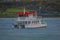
0,18,60,40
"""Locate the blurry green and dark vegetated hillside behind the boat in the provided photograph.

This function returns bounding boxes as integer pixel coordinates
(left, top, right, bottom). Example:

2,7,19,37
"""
0,0,60,17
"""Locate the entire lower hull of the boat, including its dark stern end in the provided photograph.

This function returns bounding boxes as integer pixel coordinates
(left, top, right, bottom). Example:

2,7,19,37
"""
14,24,47,29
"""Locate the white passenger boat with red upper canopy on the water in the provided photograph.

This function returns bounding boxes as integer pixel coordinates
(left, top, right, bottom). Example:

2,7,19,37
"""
14,8,47,29
